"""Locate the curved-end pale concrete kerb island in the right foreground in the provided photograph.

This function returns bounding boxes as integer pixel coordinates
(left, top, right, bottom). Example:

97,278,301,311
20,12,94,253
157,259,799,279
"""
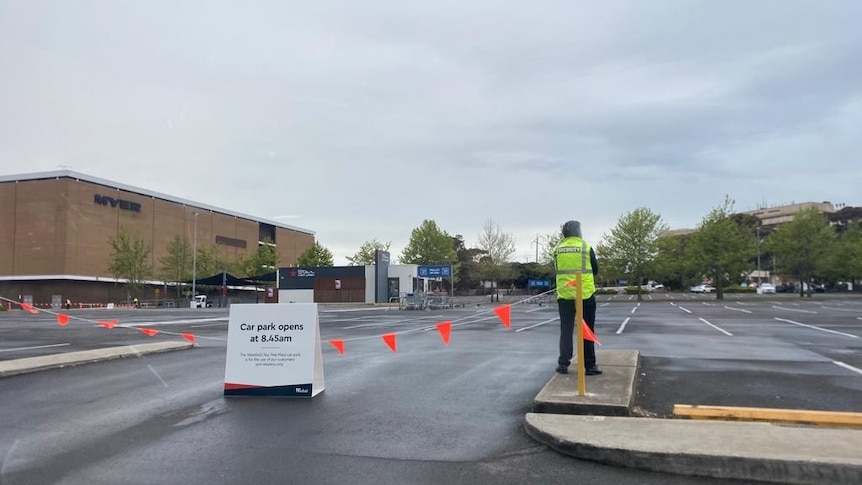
525,413,862,485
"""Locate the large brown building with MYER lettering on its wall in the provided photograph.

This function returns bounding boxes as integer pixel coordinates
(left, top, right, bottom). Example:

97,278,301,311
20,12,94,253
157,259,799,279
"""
0,170,314,304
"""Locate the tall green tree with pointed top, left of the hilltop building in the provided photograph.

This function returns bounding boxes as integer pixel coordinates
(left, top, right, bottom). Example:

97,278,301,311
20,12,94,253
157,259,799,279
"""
688,197,756,300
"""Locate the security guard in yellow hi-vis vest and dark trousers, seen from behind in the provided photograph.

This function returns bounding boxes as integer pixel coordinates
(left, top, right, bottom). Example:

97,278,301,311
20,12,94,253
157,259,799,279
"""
554,221,602,376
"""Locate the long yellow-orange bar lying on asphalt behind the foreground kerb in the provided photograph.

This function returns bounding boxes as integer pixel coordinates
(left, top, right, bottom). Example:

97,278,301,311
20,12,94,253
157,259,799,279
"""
673,404,862,426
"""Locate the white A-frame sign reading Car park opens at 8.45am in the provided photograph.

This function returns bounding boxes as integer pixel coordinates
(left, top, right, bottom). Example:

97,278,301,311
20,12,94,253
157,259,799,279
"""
224,303,324,398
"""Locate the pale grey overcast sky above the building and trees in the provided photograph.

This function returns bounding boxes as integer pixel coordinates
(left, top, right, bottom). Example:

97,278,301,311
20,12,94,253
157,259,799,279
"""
0,0,862,264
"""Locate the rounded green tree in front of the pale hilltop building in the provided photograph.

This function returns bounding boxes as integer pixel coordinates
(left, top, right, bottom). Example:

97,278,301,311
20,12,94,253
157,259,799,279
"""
766,207,835,296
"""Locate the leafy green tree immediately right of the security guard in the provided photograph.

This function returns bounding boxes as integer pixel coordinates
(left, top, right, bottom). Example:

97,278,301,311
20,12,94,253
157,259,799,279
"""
597,207,667,301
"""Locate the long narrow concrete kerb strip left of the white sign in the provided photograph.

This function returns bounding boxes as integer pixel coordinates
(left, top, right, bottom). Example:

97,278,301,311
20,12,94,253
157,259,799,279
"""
0,342,194,377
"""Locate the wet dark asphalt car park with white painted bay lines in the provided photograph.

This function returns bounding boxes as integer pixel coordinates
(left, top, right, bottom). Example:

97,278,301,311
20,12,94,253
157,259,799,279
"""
0,293,862,485
